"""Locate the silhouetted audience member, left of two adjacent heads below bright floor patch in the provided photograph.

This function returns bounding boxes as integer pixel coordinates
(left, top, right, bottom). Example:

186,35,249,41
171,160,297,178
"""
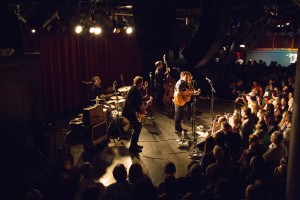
104,164,133,200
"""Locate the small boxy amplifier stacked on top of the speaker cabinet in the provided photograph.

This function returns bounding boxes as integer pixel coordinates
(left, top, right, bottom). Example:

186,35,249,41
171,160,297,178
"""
82,105,105,126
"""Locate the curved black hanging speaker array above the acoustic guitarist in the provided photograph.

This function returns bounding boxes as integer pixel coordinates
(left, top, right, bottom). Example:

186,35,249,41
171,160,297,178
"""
182,0,232,68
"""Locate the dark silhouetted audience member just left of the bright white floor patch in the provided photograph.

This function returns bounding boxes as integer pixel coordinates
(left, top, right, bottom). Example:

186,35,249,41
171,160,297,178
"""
75,162,105,200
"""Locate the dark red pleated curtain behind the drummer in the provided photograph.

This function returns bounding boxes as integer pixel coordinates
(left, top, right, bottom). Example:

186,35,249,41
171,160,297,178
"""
23,33,143,116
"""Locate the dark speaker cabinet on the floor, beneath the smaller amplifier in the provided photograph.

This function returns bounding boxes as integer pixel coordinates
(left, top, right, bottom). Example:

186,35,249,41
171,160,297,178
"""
83,121,108,146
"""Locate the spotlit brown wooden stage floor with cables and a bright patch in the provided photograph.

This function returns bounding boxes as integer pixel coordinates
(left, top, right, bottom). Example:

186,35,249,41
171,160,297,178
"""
71,99,234,186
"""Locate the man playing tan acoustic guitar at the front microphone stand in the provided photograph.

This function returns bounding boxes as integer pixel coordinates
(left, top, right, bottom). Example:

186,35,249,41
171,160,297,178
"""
174,71,200,134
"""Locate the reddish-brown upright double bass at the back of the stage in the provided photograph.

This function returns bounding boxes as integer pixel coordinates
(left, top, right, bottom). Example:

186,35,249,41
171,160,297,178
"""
162,54,176,107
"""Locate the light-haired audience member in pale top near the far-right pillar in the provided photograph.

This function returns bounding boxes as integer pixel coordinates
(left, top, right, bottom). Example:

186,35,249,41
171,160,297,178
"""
263,131,287,178
